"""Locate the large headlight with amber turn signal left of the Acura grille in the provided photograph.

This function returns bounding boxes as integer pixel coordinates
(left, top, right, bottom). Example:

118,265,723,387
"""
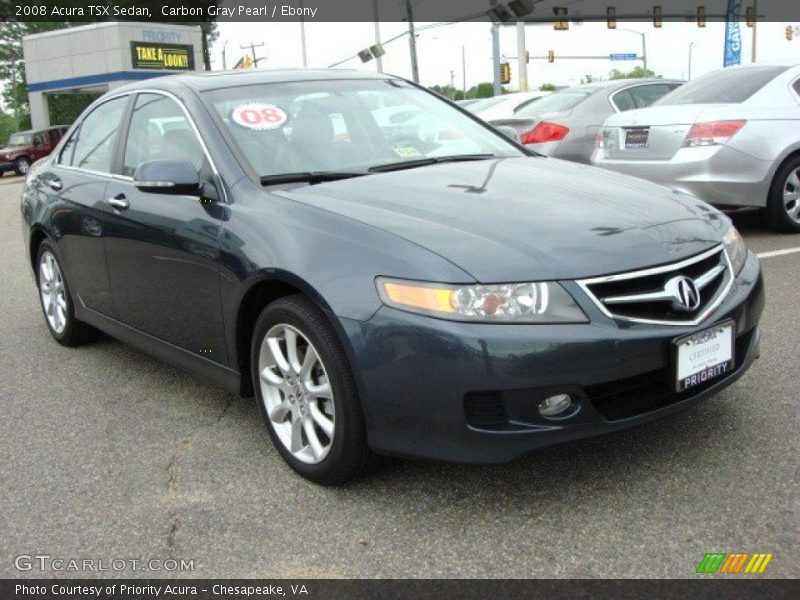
377,277,588,323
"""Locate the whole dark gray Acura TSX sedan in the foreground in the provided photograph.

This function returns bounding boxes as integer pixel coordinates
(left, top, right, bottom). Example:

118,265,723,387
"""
22,70,764,484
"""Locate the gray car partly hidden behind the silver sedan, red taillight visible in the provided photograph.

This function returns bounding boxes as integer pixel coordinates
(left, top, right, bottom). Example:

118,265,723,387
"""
489,79,682,163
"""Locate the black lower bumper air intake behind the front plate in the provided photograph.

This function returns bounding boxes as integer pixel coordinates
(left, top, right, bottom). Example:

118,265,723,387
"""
585,328,756,421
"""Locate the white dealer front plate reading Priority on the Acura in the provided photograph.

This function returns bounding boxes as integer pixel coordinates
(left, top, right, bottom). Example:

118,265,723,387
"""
673,321,736,392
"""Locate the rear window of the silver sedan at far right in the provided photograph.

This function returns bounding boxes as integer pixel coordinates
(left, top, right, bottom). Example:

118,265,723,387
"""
655,66,788,106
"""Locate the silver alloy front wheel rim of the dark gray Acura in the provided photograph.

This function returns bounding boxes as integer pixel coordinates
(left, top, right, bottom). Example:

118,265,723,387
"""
258,323,336,464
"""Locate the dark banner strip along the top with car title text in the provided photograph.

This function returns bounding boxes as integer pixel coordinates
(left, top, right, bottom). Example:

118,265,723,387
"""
0,0,800,22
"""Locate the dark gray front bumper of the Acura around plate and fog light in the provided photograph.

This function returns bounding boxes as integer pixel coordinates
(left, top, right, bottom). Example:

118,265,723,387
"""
342,253,764,463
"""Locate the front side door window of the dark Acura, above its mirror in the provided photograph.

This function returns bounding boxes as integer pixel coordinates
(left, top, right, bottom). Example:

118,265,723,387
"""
122,94,205,177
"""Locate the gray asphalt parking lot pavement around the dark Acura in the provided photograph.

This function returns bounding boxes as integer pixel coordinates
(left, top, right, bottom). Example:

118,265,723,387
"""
0,176,800,578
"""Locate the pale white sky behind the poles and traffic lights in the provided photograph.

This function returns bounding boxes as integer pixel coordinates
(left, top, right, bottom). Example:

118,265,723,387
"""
212,22,800,89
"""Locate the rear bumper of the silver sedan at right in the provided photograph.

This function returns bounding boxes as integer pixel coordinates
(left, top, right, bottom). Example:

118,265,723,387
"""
591,145,772,207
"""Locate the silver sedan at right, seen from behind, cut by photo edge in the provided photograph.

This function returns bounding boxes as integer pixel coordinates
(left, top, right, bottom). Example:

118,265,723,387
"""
592,65,800,233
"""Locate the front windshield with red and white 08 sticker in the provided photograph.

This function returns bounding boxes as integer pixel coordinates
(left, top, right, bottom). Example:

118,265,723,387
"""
205,79,524,180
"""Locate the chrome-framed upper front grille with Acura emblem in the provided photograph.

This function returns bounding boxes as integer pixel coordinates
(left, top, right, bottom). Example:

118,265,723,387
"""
578,246,733,325
